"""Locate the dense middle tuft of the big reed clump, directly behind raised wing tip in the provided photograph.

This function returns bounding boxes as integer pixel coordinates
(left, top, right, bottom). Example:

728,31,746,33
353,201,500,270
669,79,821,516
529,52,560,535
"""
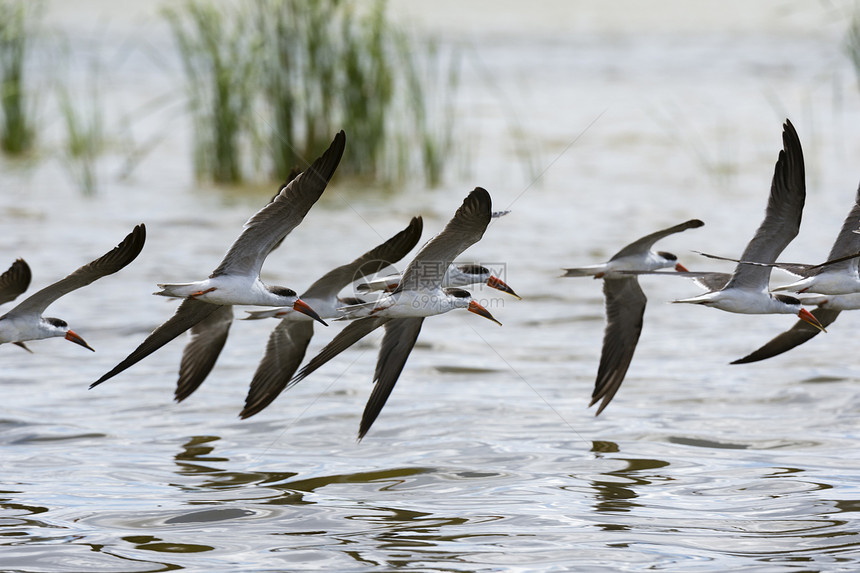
255,0,398,177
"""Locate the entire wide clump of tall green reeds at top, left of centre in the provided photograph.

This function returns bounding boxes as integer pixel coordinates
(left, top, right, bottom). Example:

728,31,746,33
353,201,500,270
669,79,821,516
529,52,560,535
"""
167,0,464,185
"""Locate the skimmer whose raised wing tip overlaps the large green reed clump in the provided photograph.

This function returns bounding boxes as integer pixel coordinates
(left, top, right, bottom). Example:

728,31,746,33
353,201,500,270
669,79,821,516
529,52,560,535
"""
90,131,346,388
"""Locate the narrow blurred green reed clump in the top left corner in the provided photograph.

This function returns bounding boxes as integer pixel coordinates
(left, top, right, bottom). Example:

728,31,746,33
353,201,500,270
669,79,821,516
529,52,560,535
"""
0,0,42,155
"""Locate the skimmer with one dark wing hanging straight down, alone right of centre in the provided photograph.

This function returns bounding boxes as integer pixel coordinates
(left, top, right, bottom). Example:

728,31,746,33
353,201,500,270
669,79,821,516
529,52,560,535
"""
562,219,704,416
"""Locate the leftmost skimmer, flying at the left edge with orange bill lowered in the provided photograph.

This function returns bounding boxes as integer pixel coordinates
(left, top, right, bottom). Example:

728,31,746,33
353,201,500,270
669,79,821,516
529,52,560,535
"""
0,224,146,350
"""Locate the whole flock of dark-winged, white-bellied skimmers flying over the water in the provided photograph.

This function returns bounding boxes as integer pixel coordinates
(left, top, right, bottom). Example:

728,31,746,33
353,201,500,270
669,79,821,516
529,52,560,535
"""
0,120,860,439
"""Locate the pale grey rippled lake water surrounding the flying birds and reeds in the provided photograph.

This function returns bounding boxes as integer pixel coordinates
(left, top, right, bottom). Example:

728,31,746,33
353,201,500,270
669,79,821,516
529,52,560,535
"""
0,0,860,573
